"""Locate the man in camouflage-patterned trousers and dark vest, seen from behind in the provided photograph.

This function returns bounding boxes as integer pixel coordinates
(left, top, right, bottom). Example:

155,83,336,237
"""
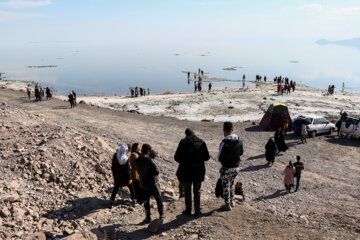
218,122,243,211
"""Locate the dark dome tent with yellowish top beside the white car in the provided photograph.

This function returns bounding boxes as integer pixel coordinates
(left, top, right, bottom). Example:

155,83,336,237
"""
260,103,292,131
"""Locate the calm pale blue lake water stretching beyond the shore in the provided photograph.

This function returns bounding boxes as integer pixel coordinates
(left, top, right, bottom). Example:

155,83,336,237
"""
0,40,360,95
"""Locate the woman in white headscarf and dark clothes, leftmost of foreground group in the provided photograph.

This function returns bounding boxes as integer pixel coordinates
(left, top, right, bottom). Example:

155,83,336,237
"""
109,144,135,208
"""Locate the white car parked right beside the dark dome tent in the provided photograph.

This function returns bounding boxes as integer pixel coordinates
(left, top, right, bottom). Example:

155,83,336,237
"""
294,115,335,137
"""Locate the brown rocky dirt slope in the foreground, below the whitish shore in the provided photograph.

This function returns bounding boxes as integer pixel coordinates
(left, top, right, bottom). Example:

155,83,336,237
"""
0,89,360,239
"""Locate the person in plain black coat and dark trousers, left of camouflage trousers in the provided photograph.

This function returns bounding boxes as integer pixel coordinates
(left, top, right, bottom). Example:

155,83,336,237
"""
174,128,210,216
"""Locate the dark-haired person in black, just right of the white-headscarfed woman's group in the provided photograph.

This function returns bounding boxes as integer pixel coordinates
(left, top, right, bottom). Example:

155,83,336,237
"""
134,144,164,223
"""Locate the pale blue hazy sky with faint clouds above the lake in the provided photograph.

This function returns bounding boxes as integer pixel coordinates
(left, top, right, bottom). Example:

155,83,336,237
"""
0,0,360,47
